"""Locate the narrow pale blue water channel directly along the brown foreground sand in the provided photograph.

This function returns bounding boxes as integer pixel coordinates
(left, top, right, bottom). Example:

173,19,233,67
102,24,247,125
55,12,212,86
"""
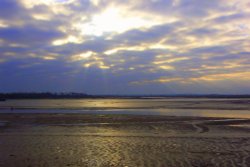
0,109,250,118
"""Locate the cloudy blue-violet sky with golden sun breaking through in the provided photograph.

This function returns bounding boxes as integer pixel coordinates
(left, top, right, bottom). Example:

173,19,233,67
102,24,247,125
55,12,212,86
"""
0,0,250,94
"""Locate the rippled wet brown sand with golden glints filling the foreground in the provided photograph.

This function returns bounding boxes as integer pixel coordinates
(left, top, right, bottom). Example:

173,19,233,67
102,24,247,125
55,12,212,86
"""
0,114,250,167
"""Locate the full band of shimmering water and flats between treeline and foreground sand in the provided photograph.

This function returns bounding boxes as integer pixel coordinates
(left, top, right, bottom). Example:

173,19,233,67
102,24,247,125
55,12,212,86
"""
0,98,250,118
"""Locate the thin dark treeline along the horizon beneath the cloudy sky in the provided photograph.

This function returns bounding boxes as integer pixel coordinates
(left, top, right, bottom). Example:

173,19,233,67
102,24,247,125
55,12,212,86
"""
0,92,250,100
